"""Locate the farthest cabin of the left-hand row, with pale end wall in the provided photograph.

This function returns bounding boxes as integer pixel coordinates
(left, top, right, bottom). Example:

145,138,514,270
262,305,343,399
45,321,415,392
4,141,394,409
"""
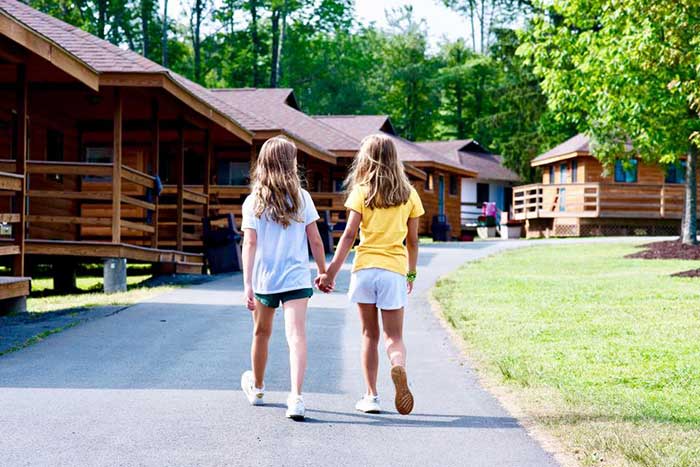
418,139,520,228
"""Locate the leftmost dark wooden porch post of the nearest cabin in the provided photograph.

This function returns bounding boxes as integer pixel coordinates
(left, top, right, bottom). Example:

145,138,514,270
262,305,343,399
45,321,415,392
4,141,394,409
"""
12,65,29,277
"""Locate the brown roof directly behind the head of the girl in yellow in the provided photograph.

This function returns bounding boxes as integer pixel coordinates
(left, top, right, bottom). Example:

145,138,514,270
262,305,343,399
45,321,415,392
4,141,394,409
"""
316,115,476,176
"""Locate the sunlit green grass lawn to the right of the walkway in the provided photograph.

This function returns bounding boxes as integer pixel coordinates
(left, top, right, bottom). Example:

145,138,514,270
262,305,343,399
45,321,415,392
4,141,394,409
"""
434,244,700,467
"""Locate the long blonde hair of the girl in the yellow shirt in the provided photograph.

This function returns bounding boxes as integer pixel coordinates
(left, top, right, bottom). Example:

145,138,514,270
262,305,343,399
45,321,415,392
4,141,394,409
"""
345,134,411,209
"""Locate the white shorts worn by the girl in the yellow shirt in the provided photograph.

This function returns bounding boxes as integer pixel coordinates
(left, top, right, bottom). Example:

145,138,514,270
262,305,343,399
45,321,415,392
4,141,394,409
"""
348,268,408,310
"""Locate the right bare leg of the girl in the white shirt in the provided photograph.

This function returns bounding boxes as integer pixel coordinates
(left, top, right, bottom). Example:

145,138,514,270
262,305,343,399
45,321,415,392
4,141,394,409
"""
283,298,309,395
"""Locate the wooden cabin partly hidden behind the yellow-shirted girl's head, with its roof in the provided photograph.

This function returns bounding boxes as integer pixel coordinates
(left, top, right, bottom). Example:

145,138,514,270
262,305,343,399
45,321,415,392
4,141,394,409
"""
316,115,477,237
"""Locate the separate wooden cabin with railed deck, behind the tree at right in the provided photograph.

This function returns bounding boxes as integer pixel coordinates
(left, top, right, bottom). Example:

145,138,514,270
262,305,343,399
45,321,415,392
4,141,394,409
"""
513,134,696,237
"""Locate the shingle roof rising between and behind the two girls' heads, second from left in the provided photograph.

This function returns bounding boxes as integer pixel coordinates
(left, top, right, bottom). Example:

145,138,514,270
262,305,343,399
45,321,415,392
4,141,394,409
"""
212,88,360,151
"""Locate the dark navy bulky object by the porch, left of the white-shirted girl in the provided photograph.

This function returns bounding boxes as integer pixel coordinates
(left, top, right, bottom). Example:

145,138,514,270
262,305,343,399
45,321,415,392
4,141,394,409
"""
203,214,242,274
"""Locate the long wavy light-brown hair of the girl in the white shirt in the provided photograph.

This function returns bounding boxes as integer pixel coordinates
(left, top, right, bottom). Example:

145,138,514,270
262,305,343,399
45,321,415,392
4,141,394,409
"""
252,136,302,228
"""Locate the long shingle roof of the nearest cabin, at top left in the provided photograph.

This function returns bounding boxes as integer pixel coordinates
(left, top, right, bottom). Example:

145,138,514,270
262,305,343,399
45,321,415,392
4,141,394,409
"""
0,0,279,135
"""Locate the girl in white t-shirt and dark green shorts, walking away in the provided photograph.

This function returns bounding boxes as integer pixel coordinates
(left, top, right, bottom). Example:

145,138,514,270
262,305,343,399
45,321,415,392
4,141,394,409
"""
241,137,326,420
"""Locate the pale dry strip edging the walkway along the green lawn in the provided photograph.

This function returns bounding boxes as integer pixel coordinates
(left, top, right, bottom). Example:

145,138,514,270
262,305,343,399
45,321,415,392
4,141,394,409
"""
427,249,582,467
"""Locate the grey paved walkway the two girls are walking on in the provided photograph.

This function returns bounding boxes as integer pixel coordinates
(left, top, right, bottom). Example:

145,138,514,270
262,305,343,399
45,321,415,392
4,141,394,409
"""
0,242,656,467
